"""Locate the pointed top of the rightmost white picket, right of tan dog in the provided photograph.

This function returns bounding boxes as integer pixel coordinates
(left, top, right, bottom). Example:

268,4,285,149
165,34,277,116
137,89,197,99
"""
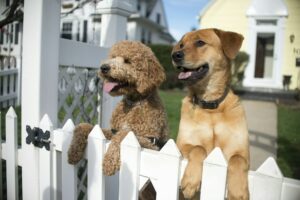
256,157,283,178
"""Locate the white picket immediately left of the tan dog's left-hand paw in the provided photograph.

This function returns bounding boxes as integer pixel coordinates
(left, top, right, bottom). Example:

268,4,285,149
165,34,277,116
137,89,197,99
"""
154,139,181,200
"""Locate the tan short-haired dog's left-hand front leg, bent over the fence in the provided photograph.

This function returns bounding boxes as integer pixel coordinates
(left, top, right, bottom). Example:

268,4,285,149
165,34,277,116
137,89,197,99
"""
181,145,207,199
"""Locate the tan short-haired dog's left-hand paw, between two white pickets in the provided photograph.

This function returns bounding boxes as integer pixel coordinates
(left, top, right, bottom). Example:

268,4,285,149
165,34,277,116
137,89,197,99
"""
181,170,201,199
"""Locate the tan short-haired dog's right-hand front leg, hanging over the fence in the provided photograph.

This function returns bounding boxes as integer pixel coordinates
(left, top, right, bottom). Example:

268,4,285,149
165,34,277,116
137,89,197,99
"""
227,155,249,200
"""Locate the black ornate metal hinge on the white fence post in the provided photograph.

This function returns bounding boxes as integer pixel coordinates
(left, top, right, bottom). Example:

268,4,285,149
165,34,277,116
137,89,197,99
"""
26,126,51,151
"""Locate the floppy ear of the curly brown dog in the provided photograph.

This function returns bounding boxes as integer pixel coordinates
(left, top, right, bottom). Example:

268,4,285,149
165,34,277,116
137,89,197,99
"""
137,54,166,94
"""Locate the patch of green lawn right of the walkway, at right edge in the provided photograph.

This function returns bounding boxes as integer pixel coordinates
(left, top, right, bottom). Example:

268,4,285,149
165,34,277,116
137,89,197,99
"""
277,105,300,179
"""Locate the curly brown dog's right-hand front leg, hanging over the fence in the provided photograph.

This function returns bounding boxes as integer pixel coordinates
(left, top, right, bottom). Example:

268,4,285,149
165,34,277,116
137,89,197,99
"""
103,131,128,176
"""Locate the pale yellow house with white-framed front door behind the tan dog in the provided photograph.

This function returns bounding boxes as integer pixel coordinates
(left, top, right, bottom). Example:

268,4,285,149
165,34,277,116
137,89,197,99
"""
199,0,300,89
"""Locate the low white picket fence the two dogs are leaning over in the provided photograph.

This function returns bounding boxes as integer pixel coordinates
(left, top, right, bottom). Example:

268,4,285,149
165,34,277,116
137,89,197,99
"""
0,108,300,200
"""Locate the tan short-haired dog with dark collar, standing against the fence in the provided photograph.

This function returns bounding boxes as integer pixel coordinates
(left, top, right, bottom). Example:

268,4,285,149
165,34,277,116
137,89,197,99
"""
172,29,249,200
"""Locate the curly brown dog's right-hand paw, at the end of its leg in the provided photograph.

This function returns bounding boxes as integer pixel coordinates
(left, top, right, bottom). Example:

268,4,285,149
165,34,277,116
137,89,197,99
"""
103,154,120,176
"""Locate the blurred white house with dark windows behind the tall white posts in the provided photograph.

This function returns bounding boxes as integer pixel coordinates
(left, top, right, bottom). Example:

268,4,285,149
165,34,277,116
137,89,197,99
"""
61,0,175,44
